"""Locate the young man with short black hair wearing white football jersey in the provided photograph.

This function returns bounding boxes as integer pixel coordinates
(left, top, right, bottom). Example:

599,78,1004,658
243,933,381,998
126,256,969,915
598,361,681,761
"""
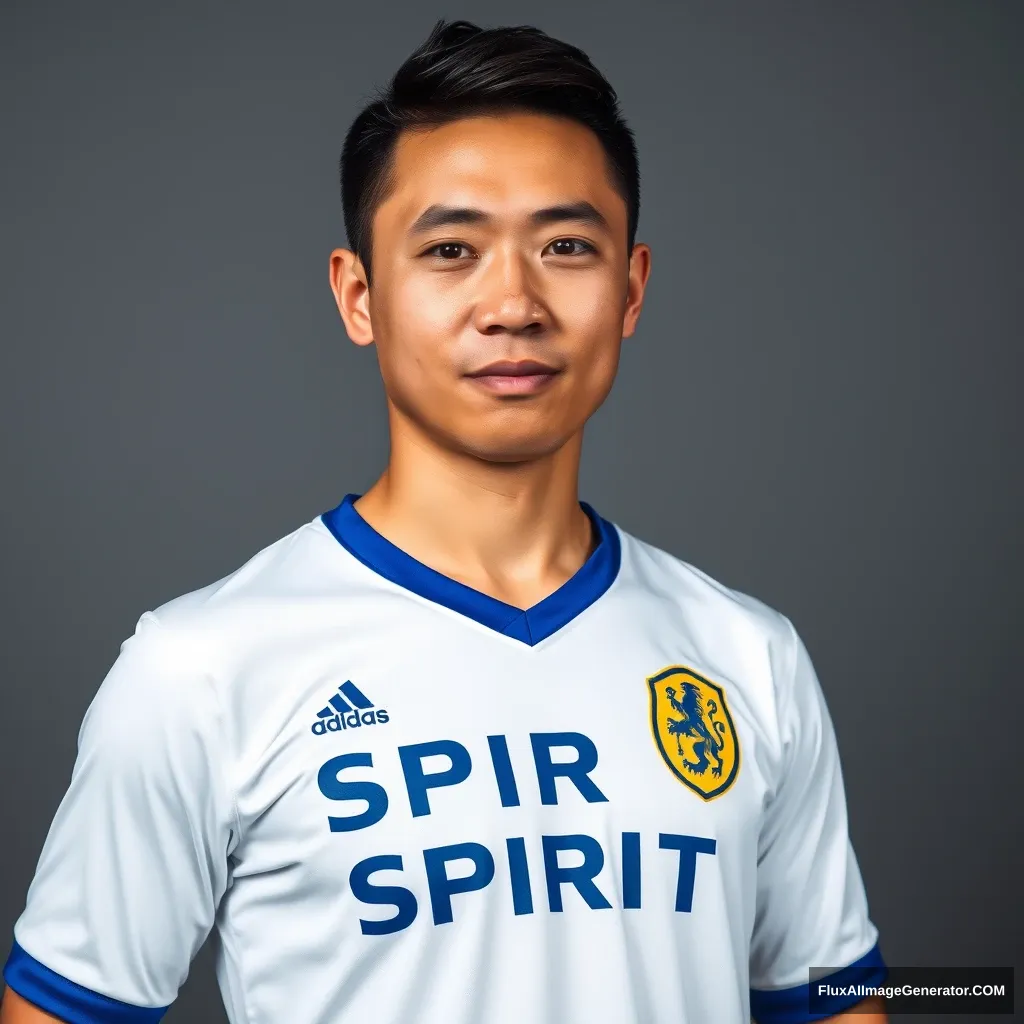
2,22,885,1024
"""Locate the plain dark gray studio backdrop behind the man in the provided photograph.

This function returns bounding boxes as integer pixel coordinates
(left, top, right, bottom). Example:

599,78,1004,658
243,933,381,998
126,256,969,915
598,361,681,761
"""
0,0,1024,1024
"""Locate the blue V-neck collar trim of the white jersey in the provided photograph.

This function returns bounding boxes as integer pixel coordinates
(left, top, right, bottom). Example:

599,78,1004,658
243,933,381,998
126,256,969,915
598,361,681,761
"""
321,495,622,646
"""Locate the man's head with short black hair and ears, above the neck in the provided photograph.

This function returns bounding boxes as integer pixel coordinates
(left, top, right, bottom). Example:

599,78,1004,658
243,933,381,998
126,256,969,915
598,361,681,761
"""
331,22,649,462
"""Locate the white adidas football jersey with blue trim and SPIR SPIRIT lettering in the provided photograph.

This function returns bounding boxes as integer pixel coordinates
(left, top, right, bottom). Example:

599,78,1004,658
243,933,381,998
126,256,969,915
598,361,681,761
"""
4,495,886,1024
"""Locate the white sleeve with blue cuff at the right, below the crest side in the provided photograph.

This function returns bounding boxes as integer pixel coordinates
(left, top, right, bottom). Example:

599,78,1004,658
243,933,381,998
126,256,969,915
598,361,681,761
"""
750,620,886,1024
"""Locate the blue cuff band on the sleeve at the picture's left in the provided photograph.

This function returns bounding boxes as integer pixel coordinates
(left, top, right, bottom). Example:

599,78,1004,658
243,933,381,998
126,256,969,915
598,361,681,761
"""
3,942,168,1024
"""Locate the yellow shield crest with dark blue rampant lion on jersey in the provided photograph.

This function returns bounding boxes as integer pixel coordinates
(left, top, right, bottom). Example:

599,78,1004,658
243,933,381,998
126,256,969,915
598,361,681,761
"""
647,665,739,800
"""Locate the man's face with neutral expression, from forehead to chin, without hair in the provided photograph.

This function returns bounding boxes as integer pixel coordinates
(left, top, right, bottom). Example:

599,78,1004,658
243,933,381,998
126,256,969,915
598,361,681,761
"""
339,114,648,462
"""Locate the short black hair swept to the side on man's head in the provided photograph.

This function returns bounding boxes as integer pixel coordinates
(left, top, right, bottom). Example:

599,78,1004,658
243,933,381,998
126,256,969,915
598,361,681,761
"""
340,18,640,283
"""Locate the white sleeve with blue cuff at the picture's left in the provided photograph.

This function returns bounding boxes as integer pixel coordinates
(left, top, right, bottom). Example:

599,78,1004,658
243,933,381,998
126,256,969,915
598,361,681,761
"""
4,613,238,1024
